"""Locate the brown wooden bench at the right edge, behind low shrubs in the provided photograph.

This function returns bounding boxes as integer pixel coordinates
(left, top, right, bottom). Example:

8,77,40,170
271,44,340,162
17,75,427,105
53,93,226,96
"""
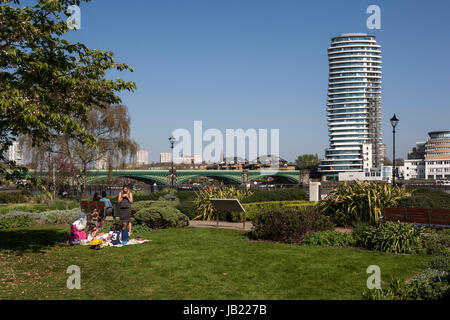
383,208,450,228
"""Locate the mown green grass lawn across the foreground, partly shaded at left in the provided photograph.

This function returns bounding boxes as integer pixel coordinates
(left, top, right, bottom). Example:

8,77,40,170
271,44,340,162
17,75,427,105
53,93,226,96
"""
0,226,431,299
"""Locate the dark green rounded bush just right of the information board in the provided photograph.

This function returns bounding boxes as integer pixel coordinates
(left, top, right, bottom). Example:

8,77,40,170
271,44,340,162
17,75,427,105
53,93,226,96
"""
249,209,334,243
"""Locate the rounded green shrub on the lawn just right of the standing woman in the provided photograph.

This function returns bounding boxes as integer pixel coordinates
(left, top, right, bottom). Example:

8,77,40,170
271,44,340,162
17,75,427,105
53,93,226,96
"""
134,207,189,229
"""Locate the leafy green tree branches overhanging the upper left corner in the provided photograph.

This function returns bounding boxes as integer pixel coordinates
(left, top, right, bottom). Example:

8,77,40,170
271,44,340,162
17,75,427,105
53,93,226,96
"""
0,0,136,186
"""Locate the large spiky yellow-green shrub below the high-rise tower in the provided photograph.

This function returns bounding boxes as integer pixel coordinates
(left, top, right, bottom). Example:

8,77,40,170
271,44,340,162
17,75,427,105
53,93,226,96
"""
318,181,410,226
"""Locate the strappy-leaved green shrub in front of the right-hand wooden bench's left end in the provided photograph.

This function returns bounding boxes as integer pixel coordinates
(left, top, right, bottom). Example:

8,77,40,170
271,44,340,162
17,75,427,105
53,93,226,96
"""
363,221,423,253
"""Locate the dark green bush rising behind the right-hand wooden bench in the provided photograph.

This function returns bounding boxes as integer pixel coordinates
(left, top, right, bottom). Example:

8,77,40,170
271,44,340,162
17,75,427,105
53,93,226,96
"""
398,188,450,209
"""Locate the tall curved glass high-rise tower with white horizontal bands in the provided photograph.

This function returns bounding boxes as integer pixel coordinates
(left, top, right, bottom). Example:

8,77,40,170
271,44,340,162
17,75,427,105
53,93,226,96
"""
319,33,384,180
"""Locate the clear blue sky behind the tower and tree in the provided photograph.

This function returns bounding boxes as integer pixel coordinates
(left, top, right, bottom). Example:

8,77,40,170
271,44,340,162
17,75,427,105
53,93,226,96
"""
64,0,450,161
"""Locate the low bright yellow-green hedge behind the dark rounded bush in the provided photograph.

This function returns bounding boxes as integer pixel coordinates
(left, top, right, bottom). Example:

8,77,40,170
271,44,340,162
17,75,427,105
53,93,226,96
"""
231,200,315,222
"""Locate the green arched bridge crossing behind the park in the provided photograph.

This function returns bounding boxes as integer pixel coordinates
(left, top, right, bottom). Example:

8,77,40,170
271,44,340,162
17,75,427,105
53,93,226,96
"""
30,169,300,185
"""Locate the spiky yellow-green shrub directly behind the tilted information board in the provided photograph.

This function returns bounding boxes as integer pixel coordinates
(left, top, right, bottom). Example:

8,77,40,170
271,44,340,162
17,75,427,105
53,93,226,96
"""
194,187,252,221
